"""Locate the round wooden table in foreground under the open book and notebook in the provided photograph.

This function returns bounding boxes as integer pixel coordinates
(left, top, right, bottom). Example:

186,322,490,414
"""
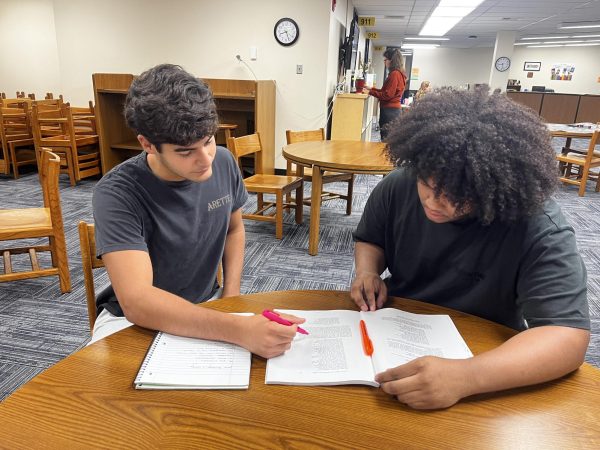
0,291,600,449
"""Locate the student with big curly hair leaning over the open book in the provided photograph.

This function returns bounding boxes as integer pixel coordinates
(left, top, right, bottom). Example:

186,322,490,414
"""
351,89,590,409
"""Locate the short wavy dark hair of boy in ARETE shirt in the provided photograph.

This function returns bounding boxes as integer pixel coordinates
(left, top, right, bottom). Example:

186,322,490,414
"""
125,64,219,151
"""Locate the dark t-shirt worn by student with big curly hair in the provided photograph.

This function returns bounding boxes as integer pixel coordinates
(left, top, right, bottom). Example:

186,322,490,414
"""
354,169,590,330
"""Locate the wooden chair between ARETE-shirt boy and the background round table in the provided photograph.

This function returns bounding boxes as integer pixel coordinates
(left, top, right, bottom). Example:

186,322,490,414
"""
227,133,303,239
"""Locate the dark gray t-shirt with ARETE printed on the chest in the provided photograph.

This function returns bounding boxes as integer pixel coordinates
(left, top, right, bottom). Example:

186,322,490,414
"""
93,147,248,316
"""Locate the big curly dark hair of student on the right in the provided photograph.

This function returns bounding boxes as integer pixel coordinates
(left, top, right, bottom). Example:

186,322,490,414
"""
388,86,557,224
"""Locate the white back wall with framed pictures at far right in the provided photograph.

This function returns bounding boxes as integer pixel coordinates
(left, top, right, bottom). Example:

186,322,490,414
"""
508,46,600,95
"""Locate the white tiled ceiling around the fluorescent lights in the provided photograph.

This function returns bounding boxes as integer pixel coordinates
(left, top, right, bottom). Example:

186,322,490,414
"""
353,0,600,47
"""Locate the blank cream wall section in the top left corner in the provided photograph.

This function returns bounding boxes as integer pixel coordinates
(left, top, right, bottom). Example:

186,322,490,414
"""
0,0,60,98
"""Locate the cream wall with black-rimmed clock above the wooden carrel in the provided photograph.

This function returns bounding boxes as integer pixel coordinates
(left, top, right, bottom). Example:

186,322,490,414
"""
54,0,329,168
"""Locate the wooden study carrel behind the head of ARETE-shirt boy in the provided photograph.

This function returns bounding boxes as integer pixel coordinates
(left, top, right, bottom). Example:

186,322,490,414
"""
92,73,275,174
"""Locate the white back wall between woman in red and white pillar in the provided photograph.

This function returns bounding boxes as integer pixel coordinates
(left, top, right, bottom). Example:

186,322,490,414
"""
411,47,494,89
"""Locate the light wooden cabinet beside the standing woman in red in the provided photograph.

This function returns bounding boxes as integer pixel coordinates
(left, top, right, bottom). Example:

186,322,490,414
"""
331,94,373,141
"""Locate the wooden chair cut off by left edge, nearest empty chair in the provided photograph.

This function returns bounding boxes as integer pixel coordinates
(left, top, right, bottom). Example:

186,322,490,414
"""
0,149,71,293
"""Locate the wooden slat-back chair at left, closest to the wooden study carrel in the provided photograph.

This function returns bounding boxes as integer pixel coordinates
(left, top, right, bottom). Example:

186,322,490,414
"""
31,103,101,186
